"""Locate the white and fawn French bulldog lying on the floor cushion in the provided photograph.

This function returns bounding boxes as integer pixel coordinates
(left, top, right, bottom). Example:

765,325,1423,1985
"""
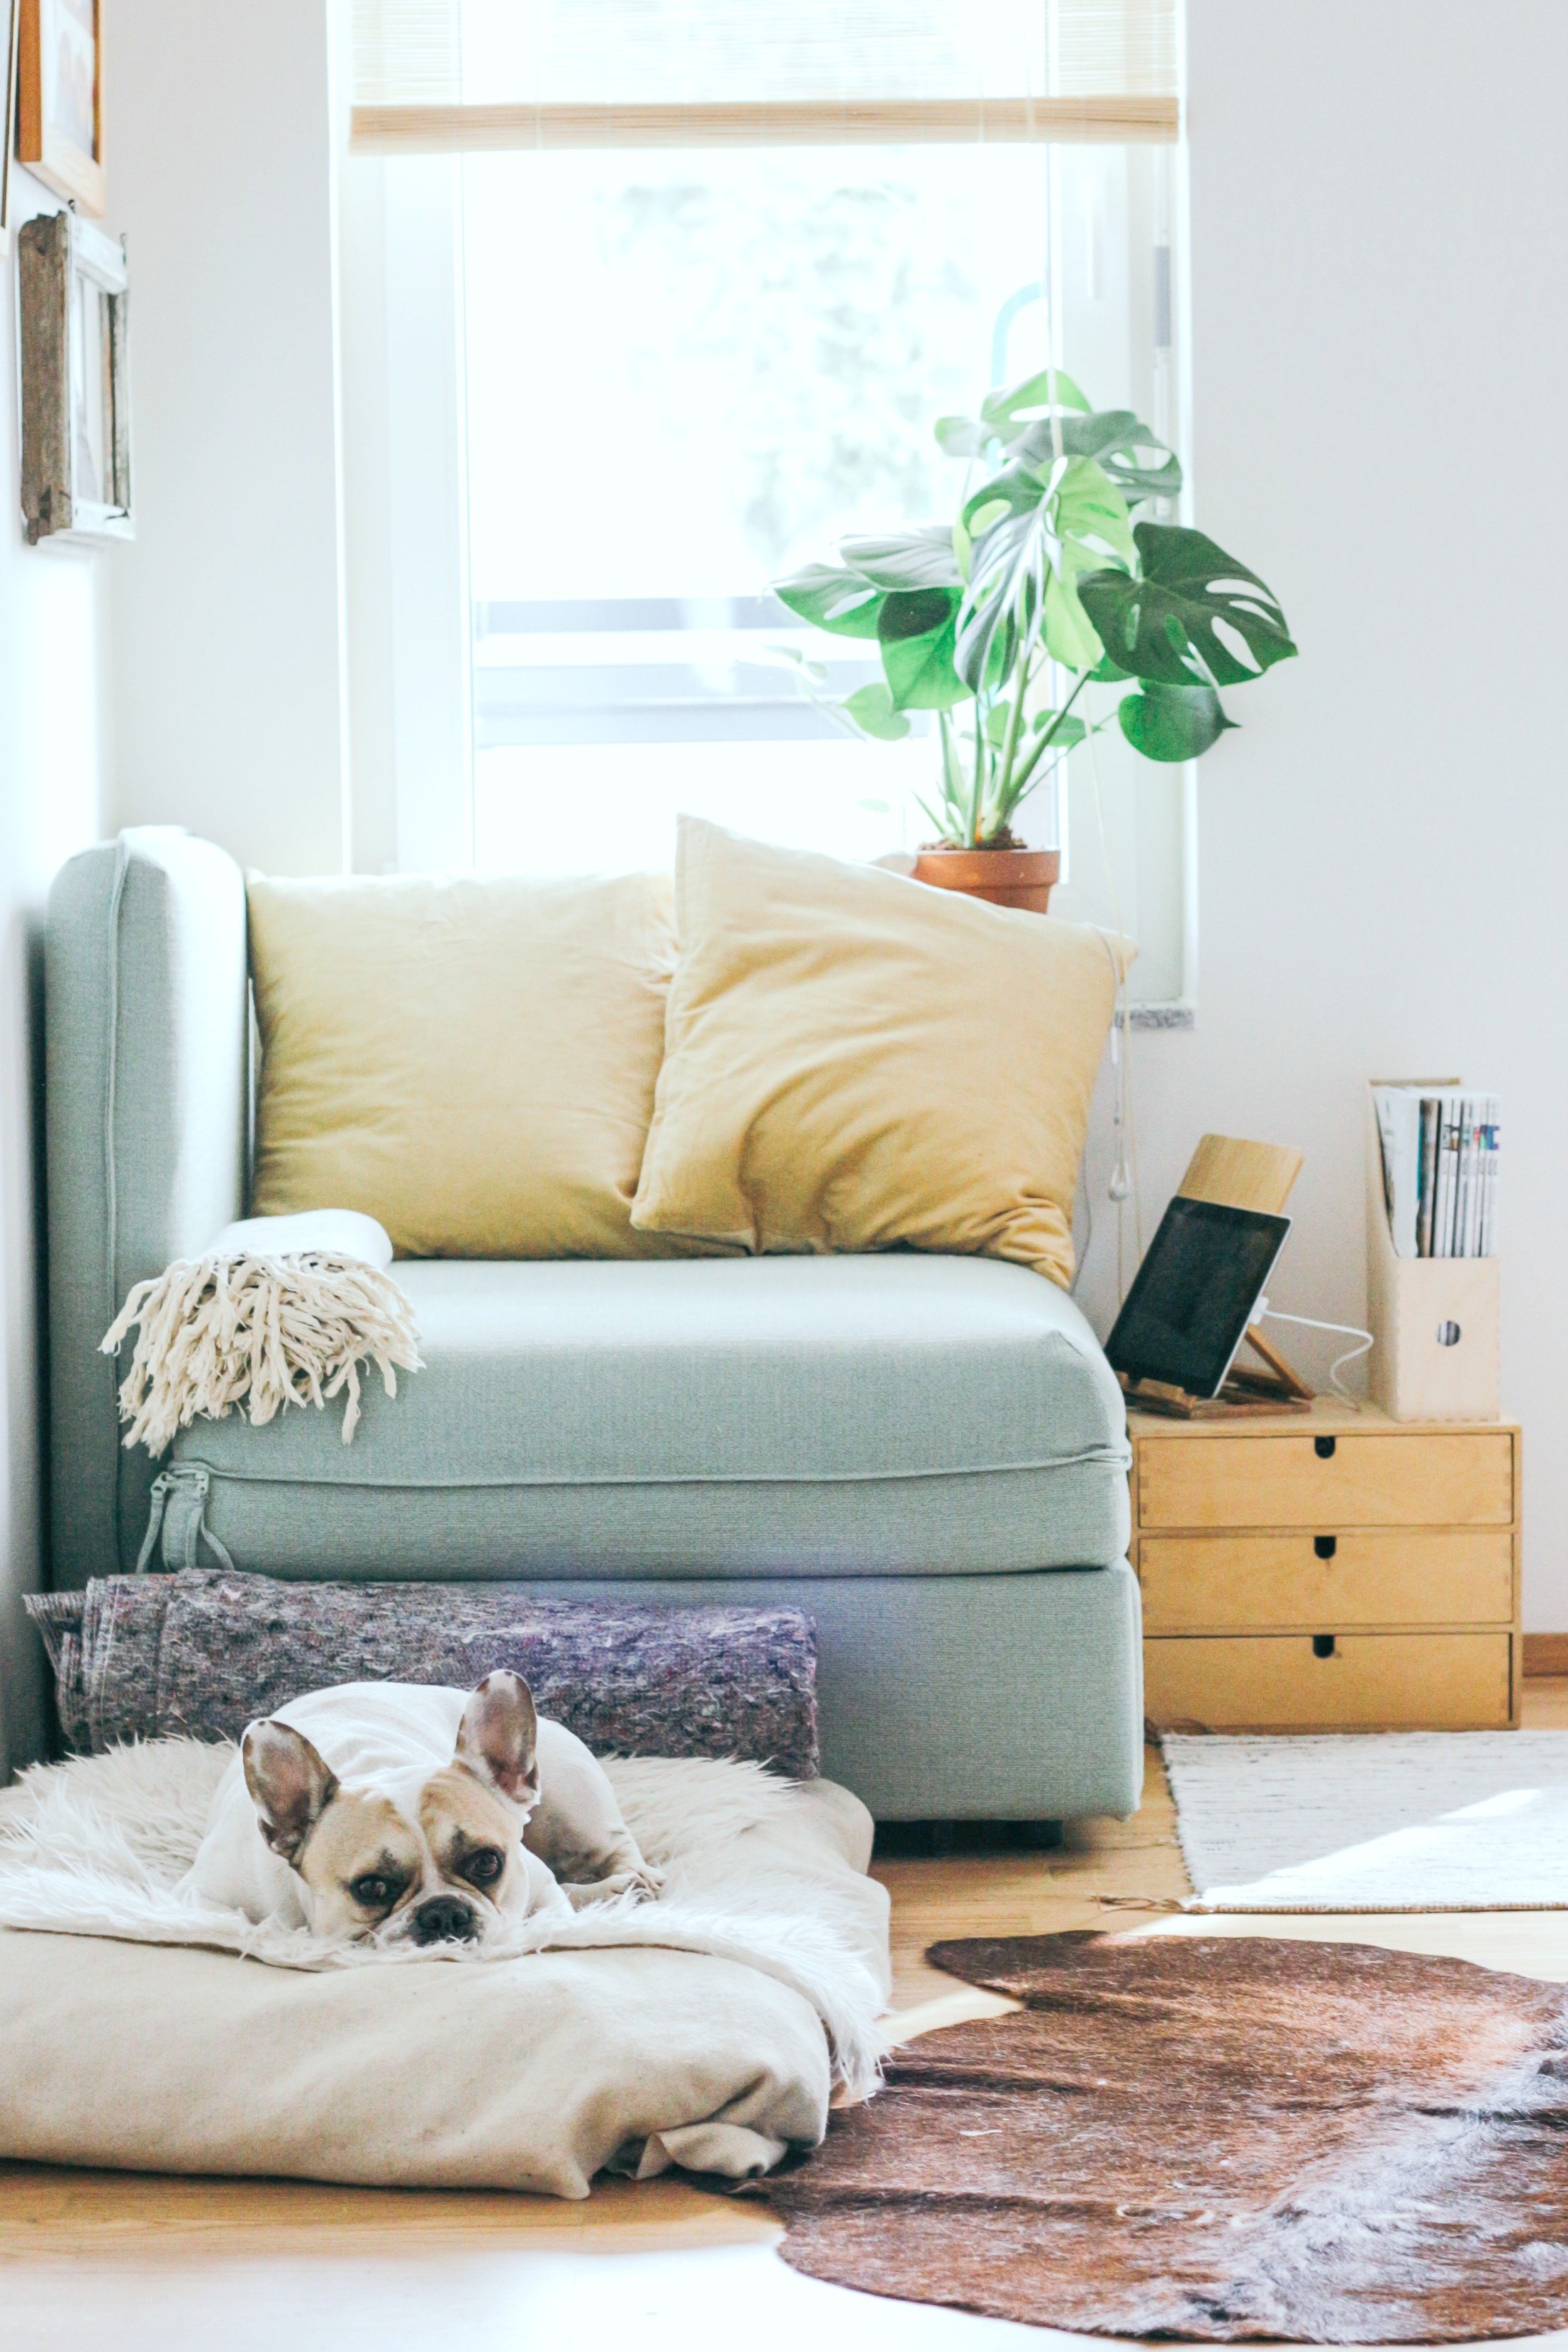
181,1670,659,1950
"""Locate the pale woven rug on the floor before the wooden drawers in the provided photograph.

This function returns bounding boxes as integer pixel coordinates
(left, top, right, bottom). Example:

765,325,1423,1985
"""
1161,1731,1568,1913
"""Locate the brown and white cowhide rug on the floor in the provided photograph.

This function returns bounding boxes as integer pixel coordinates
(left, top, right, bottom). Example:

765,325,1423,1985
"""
766,1933,1568,2345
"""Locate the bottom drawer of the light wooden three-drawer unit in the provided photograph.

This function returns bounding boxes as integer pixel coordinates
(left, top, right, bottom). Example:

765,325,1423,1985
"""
1143,1633,1514,1731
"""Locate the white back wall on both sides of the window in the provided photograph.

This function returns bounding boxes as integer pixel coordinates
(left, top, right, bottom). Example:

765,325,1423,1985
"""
86,0,1568,1628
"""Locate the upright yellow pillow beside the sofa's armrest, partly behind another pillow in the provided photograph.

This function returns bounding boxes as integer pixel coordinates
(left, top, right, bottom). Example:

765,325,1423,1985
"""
250,875,675,1258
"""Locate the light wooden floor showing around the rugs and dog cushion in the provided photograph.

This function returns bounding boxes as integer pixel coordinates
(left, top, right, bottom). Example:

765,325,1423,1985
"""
0,1679,1568,2352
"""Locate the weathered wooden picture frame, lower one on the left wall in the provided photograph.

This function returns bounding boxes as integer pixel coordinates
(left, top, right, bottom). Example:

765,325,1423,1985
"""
16,212,136,546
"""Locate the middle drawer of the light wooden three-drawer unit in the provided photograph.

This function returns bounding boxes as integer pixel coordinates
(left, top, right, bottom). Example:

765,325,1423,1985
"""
1138,1529,1514,1633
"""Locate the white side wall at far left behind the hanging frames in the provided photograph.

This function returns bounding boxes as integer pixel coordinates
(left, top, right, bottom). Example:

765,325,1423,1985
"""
0,172,116,1783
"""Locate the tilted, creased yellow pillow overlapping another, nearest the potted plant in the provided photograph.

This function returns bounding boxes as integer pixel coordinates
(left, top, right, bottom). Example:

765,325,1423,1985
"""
632,816,1133,1284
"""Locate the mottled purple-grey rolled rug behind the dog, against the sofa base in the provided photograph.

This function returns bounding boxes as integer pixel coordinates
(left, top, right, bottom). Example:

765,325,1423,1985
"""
26,1569,818,1781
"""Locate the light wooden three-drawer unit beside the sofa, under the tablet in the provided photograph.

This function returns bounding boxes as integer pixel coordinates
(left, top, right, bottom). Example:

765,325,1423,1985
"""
1131,1404,1521,1731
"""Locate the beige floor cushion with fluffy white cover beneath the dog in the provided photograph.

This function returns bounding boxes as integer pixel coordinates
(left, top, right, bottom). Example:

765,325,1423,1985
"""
0,1740,889,2197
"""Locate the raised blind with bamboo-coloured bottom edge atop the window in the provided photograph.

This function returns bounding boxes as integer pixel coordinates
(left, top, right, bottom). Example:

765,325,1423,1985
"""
350,0,1180,153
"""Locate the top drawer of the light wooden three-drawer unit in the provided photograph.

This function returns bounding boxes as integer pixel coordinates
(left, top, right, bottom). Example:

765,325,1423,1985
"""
1138,1430,1514,1533
